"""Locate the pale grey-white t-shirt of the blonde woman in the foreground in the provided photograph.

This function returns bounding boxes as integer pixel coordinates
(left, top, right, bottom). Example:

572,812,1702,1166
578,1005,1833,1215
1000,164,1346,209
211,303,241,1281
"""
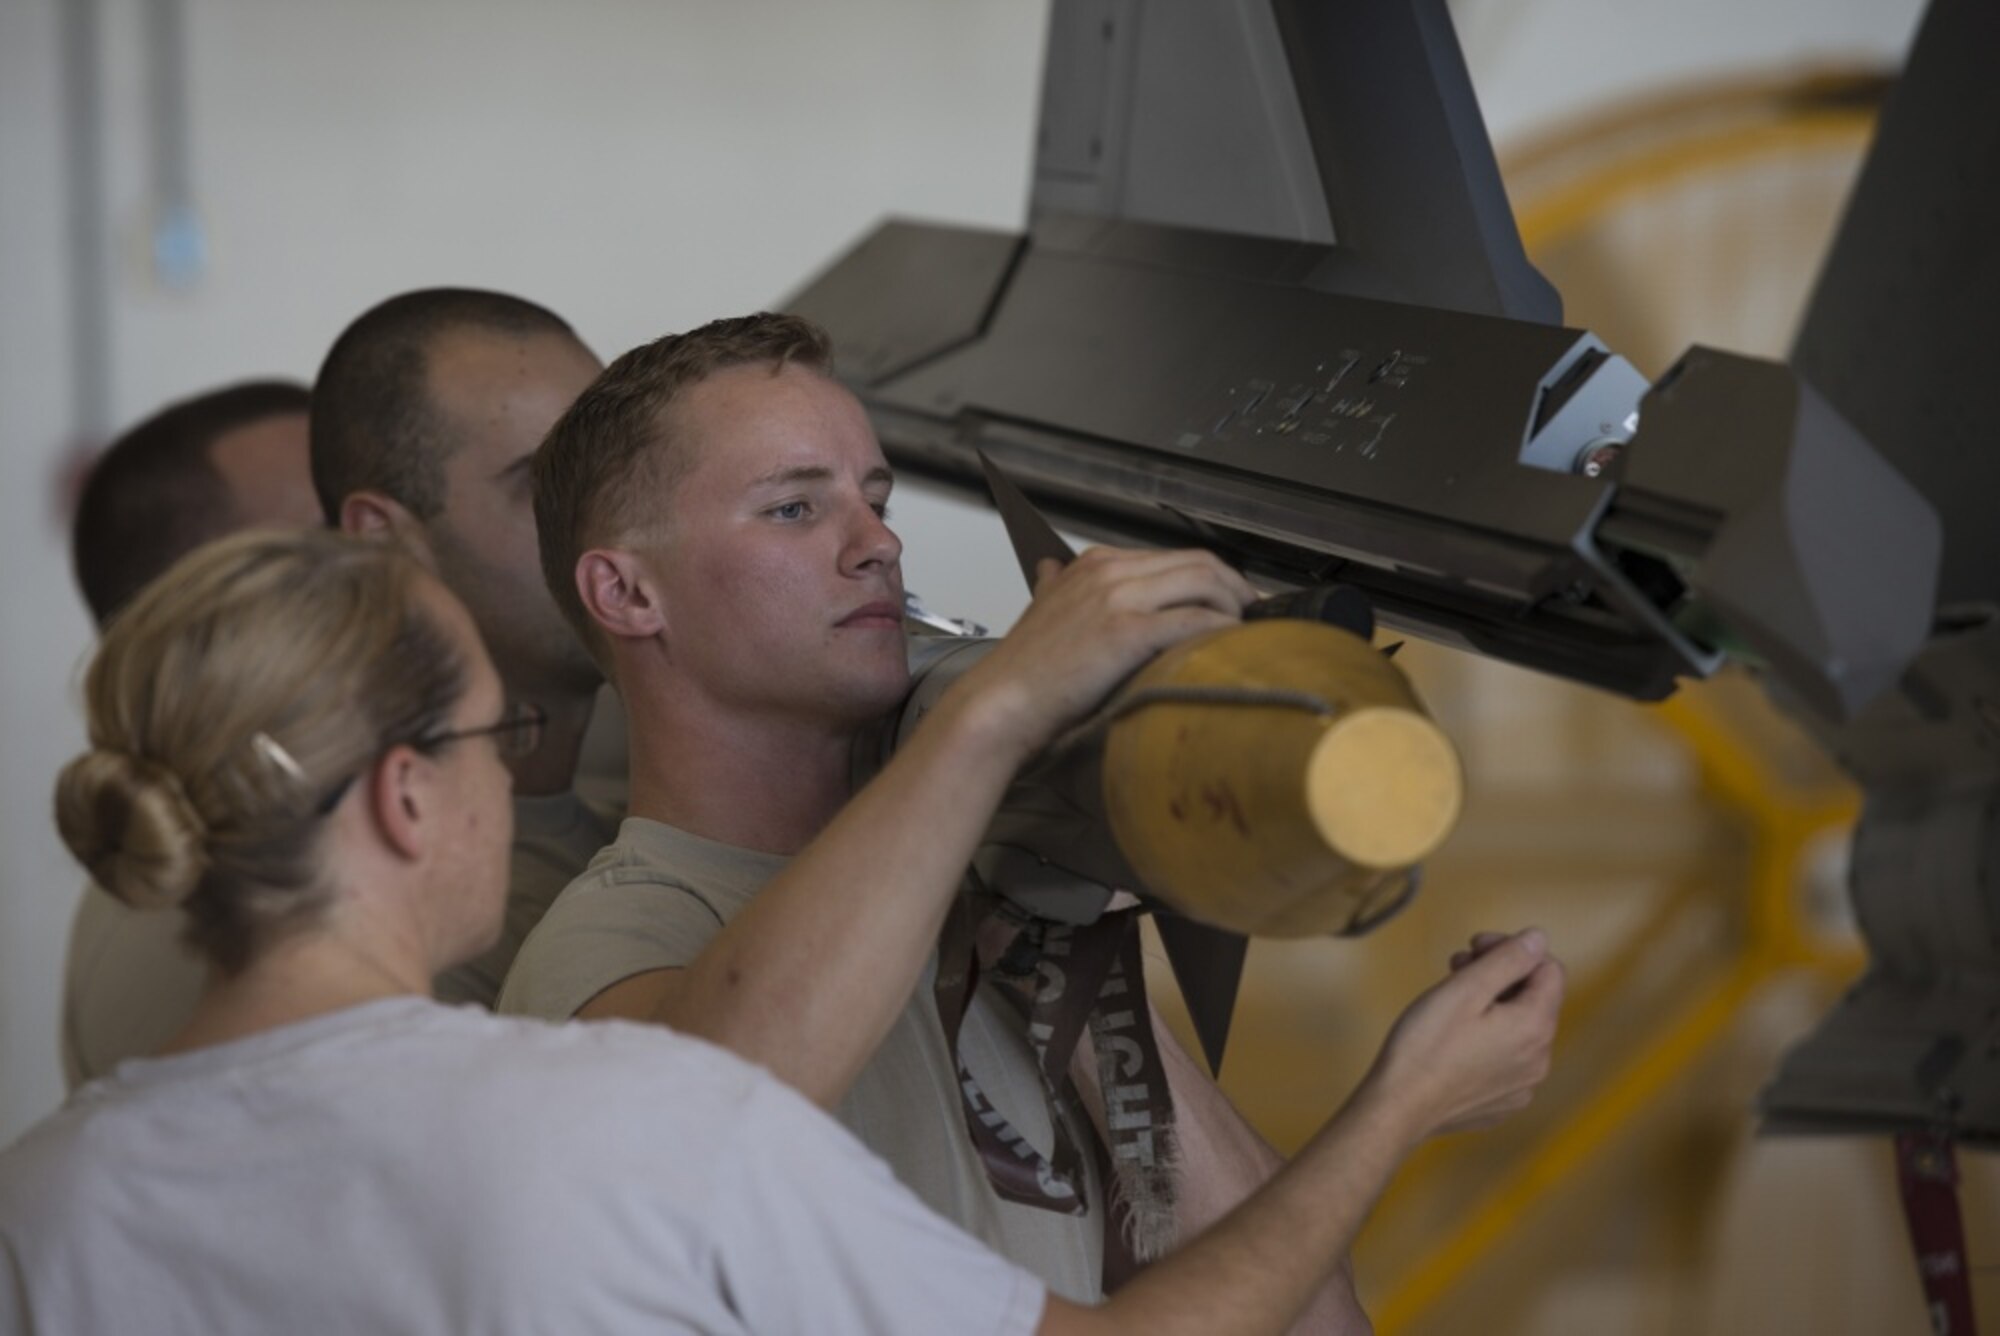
0,998,1044,1336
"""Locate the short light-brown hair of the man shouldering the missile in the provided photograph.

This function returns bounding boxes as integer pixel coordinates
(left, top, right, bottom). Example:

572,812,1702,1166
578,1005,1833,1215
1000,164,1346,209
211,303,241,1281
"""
534,312,834,672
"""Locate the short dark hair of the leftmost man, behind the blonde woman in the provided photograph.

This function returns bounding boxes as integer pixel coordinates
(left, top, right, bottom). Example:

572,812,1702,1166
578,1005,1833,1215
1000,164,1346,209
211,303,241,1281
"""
70,380,310,626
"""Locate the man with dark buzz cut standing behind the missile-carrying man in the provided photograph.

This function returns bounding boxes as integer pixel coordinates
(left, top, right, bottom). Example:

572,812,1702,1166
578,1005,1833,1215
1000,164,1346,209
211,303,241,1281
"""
312,288,622,1006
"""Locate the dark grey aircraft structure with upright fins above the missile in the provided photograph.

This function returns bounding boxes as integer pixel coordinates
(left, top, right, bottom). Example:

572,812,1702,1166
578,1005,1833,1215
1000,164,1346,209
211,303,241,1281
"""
790,0,2000,1142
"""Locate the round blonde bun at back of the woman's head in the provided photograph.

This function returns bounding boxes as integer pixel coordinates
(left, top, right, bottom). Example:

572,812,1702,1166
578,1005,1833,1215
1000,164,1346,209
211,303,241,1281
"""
56,750,208,910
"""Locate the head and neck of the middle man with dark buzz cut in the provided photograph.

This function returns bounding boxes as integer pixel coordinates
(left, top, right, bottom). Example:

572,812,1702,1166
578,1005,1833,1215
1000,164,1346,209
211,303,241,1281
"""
312,288,600,696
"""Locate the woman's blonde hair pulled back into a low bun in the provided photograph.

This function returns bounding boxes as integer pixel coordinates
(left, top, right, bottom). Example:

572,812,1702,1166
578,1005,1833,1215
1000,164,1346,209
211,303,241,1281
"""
56,534,488,976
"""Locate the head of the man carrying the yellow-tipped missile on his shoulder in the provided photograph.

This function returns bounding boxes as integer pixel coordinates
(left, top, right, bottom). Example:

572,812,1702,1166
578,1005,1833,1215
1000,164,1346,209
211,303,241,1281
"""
534,314,906,724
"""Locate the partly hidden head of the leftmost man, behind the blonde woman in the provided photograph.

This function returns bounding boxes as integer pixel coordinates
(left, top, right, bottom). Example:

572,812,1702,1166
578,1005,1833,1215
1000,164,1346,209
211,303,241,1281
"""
70,380,318,626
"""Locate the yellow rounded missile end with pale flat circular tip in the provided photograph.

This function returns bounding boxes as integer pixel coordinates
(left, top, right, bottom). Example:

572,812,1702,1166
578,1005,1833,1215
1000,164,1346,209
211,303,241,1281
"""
1104,618,1464,936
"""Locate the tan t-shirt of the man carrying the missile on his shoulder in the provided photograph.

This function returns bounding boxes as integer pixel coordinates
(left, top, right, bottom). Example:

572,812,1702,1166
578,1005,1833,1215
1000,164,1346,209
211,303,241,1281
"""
500,818,1104,1302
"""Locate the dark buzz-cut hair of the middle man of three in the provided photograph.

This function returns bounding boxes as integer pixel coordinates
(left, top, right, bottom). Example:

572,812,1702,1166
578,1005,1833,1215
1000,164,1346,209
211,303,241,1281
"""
312,288,576,524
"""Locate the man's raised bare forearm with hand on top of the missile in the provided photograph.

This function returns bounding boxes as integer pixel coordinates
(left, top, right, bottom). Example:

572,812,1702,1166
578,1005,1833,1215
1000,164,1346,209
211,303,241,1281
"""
624,548,1256,1104
